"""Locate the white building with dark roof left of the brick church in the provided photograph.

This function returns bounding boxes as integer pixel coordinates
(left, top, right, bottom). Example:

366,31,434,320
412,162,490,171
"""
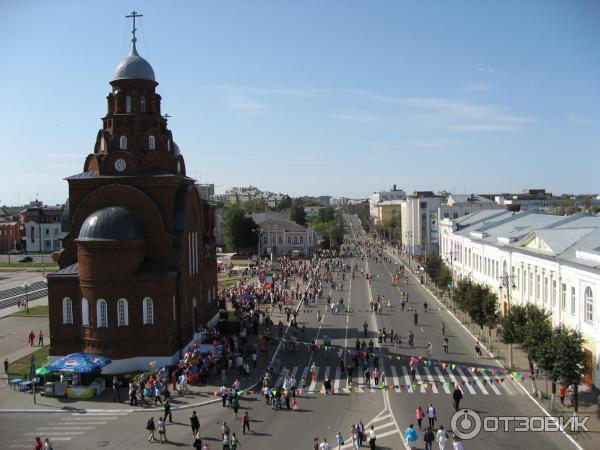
19,200,62,253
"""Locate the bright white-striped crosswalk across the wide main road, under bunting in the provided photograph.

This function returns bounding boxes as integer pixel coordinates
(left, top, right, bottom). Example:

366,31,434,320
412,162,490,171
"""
275,365,525,396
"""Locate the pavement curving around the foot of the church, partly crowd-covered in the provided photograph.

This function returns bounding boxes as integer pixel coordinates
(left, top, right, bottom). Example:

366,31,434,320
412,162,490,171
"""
0,274,308,412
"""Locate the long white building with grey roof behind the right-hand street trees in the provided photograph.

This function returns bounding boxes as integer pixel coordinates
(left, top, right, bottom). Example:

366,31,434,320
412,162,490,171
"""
440,210,600,386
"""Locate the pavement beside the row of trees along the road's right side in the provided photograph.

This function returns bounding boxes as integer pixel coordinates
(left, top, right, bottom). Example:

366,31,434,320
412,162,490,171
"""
386,246,600,448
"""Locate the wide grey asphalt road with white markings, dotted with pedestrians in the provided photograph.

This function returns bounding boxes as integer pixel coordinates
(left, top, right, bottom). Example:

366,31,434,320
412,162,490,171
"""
2,216,585,450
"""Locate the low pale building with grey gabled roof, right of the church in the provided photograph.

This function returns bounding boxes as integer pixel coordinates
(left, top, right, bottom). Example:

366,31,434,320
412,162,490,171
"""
258,219,315,257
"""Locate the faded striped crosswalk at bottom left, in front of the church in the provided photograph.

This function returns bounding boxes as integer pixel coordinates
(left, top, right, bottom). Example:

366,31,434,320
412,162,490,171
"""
10,411,129,449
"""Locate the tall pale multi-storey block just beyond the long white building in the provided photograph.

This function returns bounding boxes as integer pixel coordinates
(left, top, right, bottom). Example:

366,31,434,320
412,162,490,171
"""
400,192,443,256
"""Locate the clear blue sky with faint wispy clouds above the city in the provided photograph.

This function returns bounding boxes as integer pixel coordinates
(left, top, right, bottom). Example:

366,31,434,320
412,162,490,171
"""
0,0,600,205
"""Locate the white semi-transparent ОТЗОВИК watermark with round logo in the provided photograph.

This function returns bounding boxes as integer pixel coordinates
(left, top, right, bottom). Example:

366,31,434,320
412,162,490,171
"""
450,408,589,440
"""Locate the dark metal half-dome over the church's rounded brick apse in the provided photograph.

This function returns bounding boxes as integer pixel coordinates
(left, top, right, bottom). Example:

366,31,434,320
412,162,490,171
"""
79,206,144,241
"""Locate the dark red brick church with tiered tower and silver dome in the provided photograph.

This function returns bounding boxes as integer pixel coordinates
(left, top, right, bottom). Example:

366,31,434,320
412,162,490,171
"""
48,14,217,373
